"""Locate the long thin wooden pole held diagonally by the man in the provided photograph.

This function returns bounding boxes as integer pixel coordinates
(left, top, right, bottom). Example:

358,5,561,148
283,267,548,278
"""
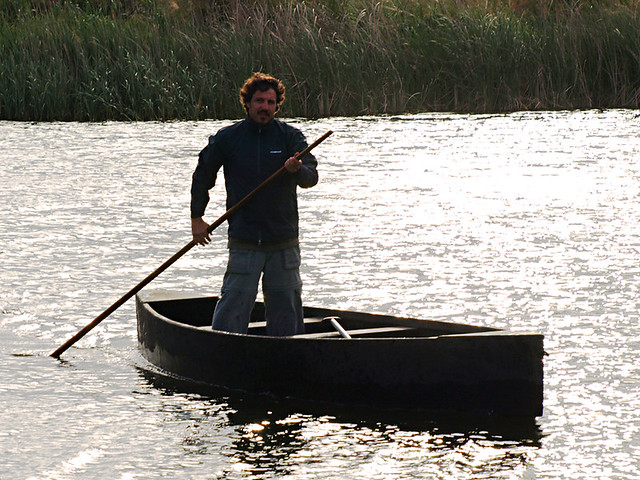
51,130,333,358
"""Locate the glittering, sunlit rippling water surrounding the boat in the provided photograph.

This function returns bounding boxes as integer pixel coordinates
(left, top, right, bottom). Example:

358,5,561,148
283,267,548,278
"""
0,111,640,480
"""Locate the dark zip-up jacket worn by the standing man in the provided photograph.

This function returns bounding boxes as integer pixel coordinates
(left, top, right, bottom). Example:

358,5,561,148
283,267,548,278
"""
191,117,318,245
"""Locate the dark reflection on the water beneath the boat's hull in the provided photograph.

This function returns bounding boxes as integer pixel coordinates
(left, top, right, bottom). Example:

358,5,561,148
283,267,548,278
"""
138,365,543,442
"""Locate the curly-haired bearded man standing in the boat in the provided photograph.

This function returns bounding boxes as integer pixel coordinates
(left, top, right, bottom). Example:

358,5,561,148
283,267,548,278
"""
191,73,318,336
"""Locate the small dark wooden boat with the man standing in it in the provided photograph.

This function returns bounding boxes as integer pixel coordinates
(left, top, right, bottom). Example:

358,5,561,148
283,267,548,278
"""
136,292,544,416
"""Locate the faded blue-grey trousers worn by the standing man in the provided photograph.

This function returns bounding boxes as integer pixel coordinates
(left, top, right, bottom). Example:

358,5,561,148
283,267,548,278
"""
213,246,304,336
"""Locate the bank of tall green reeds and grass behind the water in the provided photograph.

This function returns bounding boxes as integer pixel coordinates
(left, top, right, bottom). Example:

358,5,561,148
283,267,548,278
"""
0,0,640,120
